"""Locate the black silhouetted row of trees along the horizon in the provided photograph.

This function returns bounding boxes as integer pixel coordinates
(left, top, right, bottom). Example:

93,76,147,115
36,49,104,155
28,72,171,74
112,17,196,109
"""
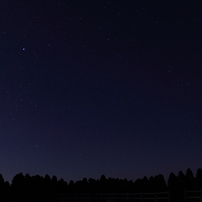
0,168,202,201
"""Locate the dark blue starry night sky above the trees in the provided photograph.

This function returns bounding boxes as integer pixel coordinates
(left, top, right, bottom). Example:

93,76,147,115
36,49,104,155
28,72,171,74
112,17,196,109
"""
0,0,202,182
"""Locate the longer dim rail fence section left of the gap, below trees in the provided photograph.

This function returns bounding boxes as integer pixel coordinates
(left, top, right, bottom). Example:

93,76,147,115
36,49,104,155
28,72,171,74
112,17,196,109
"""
56,192,169,202
